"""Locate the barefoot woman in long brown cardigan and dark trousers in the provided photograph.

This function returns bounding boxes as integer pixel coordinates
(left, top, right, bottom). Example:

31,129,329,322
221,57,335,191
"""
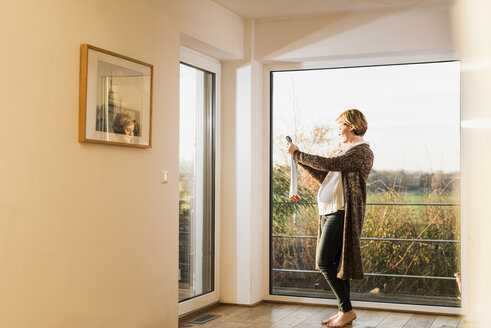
288,109,373,327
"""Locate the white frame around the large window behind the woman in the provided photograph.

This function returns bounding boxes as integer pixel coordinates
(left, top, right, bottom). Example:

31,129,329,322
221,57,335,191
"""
263,52,468,315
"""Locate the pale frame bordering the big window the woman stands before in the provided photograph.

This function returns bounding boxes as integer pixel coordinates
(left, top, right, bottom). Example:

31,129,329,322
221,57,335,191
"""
263,59,467,315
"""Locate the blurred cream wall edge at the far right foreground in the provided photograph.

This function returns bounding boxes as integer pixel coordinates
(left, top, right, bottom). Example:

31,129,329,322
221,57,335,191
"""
453,0,491,327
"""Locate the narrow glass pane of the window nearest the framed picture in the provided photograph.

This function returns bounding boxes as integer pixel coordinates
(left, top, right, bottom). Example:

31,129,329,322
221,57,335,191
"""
179,64,215,302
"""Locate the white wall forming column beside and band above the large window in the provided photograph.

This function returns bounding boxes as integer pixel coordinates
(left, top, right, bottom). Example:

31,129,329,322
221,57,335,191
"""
221,1,462,304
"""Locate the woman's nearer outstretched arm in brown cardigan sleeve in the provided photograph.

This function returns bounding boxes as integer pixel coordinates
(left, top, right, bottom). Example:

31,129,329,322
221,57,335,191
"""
293,145,373,174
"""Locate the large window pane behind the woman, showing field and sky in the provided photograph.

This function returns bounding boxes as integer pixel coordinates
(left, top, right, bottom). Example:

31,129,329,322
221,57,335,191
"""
270,62,461,307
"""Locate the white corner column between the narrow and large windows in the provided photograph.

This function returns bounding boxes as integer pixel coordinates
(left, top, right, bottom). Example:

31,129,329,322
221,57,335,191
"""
221,21,267,304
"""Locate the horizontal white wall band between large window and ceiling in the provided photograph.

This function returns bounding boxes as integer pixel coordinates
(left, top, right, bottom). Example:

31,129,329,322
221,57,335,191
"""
255,5,454,65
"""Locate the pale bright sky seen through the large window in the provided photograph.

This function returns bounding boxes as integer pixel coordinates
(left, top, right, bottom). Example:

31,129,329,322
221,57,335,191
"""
272,62,460,172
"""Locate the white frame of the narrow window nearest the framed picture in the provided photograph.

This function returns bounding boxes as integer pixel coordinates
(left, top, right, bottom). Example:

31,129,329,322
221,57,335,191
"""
179,46,221,317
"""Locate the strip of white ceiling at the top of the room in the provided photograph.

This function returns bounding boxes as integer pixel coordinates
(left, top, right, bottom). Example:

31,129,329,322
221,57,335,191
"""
213,0,452,19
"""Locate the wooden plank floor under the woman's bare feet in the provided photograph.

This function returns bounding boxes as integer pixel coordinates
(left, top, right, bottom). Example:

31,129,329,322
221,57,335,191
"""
179,303,465,328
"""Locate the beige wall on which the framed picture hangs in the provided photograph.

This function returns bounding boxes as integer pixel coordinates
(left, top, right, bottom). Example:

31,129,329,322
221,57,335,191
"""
0,0,179,328
